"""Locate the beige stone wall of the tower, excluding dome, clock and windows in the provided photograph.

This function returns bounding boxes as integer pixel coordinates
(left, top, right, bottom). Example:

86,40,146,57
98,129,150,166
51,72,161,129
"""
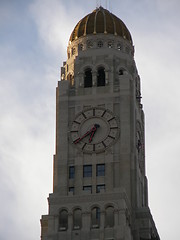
41,23,158,240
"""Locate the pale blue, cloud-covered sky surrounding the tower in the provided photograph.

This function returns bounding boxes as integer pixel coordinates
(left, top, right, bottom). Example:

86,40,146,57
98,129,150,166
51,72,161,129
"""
0,0,180,240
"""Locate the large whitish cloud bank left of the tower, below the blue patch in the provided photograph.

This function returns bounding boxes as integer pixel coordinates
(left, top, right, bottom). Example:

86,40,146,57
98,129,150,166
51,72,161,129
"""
0,6,58,240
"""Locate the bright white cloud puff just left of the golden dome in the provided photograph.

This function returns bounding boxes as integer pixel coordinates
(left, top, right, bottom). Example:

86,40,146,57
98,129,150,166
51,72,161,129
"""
30,0,85,54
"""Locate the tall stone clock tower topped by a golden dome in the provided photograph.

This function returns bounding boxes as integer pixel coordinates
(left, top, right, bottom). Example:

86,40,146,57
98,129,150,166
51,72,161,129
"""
41,7,160,240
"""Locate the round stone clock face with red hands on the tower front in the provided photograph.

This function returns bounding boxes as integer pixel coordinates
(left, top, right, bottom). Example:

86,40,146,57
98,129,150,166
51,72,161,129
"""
70,107,119,153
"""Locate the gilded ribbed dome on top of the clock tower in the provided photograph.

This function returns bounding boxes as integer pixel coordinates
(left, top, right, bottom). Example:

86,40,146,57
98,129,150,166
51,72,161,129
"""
69,7,132,44
